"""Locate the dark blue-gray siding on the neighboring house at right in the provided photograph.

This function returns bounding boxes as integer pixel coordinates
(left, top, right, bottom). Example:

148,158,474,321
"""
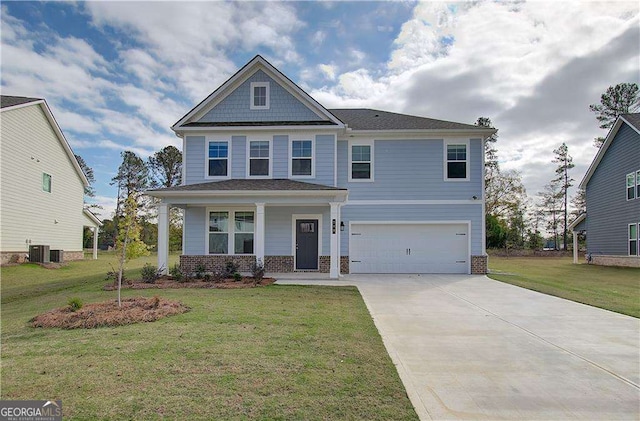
586,123,640,256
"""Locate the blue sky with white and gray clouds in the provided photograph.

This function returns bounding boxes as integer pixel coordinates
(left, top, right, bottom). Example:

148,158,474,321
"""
1,1,640,217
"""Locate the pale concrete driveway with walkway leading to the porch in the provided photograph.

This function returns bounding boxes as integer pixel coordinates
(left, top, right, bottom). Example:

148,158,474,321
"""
278,275,640,420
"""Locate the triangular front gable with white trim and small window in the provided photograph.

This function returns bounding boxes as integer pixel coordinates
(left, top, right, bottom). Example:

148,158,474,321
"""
172,55,344,133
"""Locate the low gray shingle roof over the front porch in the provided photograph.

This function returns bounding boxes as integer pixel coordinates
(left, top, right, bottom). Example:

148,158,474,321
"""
149,178,346,192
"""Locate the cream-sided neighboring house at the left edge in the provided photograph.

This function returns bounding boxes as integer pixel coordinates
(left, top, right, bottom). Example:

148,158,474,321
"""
0,95,102,263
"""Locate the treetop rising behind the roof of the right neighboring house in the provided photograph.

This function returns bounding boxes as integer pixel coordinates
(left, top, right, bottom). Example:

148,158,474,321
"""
589,83,640,147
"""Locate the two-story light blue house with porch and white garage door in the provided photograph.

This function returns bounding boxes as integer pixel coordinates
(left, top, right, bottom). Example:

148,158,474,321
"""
148,56,495,278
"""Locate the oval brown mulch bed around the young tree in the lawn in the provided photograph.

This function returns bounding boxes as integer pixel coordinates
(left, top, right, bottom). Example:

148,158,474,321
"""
29,297,190,329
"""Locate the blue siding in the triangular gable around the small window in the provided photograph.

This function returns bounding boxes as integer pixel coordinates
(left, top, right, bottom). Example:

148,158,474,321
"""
199,70,321,122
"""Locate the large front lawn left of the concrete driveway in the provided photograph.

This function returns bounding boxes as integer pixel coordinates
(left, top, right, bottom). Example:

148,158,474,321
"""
0,256,417,420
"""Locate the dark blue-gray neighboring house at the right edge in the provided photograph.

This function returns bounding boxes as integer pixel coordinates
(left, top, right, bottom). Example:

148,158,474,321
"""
570,113,640,267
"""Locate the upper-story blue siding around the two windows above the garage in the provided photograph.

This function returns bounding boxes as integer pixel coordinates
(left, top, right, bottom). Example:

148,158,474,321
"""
338,139,482,200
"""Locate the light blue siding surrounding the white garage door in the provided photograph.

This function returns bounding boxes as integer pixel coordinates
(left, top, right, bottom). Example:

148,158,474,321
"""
340,204,484,256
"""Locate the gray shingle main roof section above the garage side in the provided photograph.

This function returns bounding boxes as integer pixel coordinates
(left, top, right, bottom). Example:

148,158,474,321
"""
329,108,479,130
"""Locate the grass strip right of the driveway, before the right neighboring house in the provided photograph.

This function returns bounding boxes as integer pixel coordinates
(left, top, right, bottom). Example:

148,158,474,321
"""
489,256,640,317
